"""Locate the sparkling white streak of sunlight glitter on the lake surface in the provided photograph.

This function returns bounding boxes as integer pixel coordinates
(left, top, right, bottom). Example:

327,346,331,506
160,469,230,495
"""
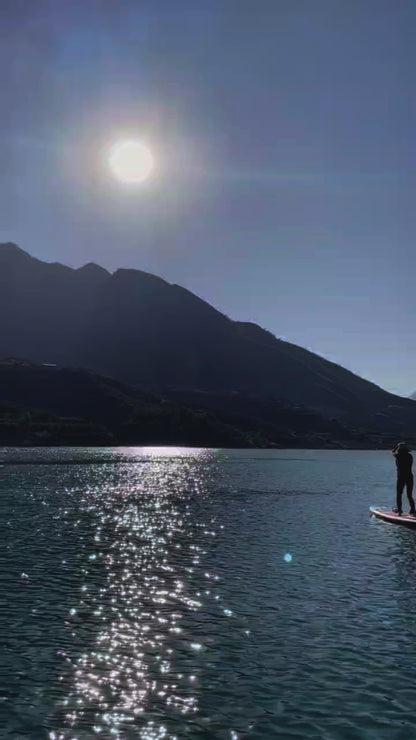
49,448,221,740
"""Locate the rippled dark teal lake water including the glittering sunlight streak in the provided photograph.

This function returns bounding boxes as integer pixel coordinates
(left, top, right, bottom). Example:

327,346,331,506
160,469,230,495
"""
0,448,416,740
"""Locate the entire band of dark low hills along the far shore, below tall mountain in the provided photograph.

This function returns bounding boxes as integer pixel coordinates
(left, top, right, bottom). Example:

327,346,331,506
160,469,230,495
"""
0,359,404,448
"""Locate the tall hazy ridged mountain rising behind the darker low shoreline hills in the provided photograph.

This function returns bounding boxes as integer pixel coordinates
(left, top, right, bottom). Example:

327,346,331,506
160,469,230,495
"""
0,244,416,446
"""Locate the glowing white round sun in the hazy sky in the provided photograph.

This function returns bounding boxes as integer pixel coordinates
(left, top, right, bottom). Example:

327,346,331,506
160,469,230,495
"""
109,141,154,183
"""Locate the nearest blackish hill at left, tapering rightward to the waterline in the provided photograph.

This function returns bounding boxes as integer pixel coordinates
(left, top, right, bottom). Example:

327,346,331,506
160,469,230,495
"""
0,359,264,447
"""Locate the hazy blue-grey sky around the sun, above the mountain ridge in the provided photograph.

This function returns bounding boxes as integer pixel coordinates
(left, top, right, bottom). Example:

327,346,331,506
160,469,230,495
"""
0,0,416,395
